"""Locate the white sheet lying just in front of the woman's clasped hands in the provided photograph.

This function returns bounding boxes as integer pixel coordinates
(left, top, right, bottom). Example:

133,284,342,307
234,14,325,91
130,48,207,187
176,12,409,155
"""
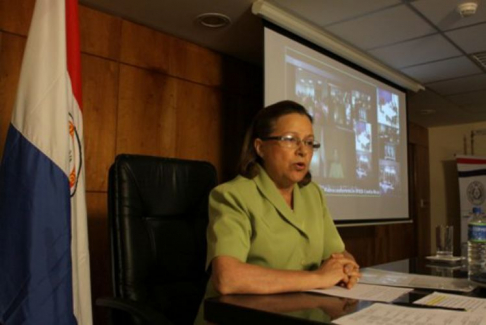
309,283,413,302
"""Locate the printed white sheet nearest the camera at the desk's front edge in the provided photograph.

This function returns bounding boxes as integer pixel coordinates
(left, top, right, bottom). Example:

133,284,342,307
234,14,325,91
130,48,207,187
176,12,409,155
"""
332,304,486,325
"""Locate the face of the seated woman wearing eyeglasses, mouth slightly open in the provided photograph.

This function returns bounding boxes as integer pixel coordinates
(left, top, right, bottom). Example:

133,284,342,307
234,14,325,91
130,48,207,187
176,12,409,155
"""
254,113,314,189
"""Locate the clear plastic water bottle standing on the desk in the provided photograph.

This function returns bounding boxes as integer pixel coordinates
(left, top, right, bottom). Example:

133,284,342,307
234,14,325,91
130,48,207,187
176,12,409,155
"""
467,207,486,280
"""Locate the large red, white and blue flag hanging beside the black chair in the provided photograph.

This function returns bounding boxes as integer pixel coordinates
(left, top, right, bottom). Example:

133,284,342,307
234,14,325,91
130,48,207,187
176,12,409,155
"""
0,0,92,325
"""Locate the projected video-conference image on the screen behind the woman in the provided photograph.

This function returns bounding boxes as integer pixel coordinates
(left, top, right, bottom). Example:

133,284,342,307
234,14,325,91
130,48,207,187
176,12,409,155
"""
286,53,402,196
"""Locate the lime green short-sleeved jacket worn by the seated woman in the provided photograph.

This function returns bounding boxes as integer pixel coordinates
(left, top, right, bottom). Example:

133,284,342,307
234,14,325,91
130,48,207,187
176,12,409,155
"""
196,168,344,324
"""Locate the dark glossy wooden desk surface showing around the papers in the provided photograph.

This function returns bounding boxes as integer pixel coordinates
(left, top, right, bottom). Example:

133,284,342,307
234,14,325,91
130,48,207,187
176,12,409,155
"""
204,259,486,325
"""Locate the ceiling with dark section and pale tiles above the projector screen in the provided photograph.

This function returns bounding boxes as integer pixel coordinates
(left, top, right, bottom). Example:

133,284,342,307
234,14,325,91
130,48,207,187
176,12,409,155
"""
80,0,486,127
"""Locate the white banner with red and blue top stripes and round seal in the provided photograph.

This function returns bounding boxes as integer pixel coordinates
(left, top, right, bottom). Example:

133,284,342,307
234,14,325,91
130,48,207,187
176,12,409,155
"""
456,156,486,252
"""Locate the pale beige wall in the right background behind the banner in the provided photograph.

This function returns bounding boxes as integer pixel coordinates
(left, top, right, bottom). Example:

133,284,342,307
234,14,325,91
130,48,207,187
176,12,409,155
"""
429,122,486,254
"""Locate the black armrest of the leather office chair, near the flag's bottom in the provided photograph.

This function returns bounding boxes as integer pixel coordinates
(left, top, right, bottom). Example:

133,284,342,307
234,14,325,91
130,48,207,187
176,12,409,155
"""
96,297,174,325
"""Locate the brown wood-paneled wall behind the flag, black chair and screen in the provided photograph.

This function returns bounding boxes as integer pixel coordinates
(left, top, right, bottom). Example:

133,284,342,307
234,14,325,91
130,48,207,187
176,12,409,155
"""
0,0,430,324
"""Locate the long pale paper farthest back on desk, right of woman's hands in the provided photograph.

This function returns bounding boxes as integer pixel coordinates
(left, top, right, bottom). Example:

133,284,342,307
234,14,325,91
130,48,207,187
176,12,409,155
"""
359,268,475,292
